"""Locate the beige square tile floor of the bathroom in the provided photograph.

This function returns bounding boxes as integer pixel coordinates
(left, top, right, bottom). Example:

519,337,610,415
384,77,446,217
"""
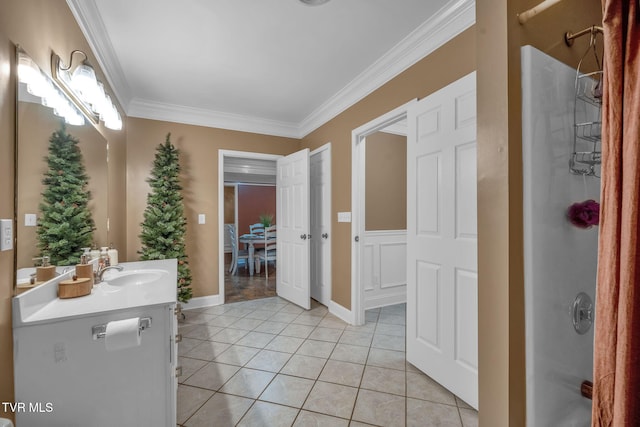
178,297,478,427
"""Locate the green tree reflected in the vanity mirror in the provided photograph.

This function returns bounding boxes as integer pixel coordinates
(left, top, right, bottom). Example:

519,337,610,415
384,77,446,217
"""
36,122,95,265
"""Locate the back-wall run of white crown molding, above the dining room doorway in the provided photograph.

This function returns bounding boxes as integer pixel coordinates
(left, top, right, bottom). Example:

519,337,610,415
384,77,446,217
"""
128,98,301,139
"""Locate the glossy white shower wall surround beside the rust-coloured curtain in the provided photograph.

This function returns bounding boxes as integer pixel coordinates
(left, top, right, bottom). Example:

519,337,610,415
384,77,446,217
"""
521,46,600,427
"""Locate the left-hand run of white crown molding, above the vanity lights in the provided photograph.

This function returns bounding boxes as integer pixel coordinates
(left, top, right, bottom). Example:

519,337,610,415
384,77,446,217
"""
67,0,131,113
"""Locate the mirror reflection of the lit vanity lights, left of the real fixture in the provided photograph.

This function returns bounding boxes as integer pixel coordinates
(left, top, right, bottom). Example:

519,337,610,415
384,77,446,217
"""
18,48,84,126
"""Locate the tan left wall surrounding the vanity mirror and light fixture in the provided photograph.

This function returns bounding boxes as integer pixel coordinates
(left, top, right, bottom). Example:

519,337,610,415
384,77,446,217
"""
0,0,126,417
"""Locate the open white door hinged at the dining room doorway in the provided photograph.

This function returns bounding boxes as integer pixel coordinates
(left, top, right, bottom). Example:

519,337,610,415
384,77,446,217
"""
276,149,311,310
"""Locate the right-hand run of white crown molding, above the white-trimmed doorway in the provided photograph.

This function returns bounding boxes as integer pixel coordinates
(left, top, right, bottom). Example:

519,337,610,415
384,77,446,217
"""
300,0,476,136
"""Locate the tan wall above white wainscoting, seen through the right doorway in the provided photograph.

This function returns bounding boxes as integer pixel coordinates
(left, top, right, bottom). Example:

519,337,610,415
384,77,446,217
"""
364,132,407,231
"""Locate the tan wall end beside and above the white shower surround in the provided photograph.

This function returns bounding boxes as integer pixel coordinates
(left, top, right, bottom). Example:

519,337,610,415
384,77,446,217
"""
476,0,602,427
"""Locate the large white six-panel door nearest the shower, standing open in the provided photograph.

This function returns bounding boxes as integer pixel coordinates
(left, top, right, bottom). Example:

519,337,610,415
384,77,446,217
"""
407,72,478,409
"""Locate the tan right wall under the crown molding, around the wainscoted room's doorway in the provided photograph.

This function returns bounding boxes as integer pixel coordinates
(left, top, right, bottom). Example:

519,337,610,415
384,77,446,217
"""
303,27,476,309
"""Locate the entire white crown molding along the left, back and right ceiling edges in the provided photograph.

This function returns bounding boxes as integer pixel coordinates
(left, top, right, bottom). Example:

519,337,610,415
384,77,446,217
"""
67,0,475,139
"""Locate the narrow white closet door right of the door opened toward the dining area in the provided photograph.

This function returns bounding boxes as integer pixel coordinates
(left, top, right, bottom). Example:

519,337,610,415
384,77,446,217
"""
310,148,331,306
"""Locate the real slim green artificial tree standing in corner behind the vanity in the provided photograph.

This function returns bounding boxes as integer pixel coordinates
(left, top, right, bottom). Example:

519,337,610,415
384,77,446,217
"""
138,133,191,302
